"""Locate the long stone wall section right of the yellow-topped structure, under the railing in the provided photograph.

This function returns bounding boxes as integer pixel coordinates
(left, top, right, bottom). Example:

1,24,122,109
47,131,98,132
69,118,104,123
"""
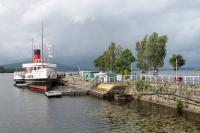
128,81,200,114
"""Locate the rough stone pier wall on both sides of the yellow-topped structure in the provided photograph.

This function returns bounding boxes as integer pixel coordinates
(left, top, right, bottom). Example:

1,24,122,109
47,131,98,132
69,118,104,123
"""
63,77,200,114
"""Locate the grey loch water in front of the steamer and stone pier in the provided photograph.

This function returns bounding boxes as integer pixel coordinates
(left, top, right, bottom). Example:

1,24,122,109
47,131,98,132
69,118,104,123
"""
0,74,200,133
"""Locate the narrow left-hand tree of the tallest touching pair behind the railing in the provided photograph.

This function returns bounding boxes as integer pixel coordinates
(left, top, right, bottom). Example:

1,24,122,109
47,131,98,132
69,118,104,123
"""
136,35,148,72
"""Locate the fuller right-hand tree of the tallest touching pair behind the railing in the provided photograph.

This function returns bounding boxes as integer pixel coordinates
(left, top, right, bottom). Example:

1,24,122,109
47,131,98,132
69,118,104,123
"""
146,32,168,70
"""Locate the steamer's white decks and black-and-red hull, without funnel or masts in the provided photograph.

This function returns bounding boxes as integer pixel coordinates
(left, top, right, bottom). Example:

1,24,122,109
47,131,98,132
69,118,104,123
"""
14,63,58,92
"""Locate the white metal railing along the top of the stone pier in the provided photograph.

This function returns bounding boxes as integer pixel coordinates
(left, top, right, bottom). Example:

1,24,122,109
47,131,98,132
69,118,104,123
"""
108,74,200,84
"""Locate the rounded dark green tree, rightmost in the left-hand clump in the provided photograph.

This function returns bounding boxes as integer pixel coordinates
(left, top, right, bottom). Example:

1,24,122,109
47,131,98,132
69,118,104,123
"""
115,49,135,74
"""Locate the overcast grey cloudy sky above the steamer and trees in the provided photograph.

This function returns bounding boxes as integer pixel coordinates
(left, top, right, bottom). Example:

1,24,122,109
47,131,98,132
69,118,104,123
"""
0,0,200,66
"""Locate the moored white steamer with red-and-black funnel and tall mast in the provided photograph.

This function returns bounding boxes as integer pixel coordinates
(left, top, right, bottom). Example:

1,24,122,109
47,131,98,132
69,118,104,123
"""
14,23,58,92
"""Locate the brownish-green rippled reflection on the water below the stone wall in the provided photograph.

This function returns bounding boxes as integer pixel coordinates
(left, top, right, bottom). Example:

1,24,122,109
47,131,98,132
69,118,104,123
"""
88,101,200,133
